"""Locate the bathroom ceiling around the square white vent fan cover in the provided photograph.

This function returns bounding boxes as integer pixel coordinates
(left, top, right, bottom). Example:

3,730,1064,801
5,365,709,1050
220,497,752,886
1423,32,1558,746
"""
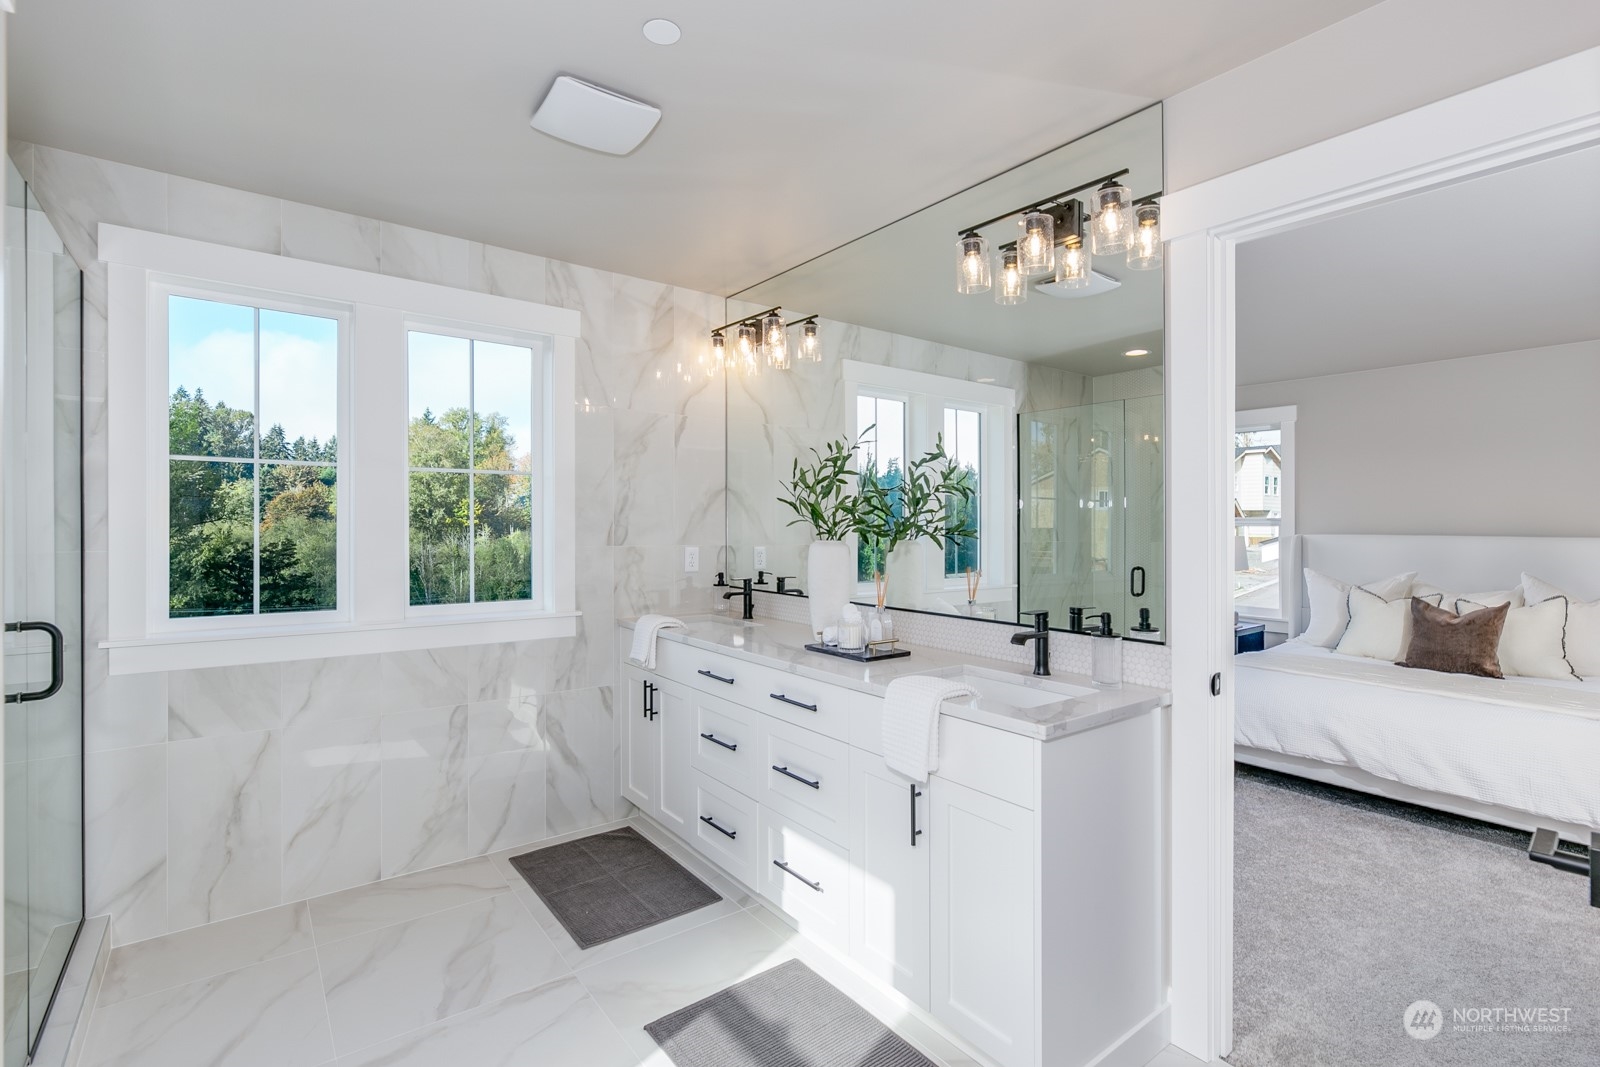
10,0,1373,293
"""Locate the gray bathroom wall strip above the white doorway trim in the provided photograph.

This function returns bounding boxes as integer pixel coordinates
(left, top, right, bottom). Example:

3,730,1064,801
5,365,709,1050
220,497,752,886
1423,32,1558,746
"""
1165,0,1600,192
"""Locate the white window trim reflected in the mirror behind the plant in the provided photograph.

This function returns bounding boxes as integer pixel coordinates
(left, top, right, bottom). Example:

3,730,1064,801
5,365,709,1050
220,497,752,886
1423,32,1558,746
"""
840,360,1018,601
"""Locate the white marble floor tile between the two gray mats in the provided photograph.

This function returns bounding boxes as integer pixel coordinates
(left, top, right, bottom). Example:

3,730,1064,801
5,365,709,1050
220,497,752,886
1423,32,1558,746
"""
578,910,797,1056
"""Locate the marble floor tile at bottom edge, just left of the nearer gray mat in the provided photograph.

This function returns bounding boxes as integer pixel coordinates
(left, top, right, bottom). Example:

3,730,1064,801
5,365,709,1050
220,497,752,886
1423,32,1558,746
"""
339,977,638,1067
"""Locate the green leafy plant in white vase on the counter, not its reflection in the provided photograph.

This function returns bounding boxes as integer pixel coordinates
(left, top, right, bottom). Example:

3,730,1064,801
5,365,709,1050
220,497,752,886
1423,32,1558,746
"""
778,440,862,633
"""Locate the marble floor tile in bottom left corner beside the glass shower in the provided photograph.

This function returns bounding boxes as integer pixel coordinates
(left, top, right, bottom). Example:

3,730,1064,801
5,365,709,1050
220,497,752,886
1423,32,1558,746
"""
82,950,333,1067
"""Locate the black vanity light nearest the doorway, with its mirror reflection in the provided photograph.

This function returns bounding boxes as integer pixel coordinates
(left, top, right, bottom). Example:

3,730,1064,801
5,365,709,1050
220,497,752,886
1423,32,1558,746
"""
955,168,1162,306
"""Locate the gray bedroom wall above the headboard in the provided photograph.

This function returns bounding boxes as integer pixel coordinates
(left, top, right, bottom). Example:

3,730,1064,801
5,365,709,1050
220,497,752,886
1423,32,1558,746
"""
1238,339,1600,537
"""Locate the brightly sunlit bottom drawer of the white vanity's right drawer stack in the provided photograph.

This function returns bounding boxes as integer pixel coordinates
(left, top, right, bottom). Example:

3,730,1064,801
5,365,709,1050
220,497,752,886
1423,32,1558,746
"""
757,808,850,952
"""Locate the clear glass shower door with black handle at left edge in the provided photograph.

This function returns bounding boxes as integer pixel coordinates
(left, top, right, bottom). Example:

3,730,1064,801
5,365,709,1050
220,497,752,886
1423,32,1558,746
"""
0,162,83,1067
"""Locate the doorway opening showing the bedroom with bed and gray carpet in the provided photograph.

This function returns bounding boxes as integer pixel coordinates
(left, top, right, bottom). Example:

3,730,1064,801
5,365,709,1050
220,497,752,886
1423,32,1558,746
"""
1226,112,1600,1067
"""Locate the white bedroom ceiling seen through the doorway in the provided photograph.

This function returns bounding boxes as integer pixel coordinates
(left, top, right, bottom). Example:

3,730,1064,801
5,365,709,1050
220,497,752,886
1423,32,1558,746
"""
1237,149,1600,386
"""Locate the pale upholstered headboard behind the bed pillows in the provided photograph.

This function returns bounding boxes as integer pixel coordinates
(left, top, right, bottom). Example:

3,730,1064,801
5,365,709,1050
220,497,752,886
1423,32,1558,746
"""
1285,534,1600,637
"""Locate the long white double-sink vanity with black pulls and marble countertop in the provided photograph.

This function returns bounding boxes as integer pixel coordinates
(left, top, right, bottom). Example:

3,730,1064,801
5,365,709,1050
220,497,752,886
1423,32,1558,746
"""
618,616,1168,1067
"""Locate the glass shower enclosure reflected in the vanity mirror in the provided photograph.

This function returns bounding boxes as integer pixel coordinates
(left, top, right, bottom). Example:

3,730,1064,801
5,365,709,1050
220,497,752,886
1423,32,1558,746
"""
1018,395,1166,641
